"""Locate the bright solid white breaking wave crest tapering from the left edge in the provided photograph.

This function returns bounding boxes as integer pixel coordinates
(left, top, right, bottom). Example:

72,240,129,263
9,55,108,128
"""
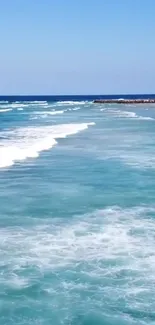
0,123,94,168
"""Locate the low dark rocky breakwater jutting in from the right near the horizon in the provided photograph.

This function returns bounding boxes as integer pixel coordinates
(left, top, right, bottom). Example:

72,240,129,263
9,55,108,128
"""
93,99,155,104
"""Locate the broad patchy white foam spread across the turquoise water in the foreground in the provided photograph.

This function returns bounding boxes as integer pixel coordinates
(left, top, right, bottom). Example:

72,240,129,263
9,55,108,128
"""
0,206,155,308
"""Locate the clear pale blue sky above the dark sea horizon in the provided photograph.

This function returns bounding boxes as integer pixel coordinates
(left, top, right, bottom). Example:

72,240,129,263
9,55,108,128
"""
0,0,155,95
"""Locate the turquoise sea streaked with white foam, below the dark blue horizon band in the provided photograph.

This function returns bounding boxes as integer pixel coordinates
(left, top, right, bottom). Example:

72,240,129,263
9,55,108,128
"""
0,101,155,325
